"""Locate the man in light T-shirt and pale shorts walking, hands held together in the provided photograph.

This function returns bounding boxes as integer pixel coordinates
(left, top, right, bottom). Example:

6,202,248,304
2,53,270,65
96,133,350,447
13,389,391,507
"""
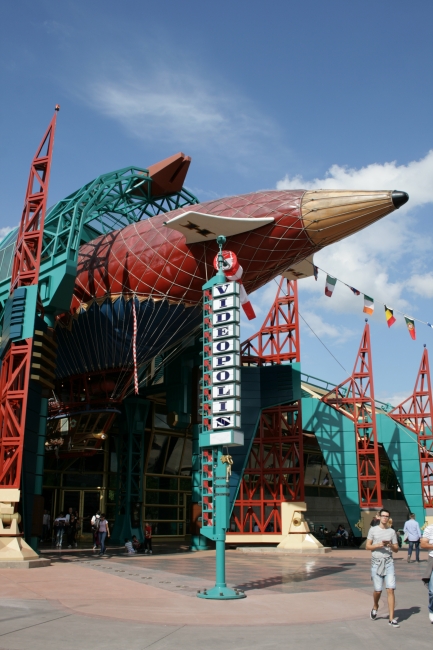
366,508,400,627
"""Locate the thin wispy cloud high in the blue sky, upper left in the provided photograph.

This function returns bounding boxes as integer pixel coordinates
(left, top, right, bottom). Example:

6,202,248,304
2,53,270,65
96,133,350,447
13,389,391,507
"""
81,64,281,165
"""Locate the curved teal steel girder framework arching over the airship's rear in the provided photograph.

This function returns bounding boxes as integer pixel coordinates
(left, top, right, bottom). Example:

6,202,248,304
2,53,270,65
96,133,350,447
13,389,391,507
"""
0,167,199,313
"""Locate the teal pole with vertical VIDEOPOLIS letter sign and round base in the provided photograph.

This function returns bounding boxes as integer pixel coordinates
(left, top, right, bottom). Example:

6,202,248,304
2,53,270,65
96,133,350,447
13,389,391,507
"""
197,236,245,600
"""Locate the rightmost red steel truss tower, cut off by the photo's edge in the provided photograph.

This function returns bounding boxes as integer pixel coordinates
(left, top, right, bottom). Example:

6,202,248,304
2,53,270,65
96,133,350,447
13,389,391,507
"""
388,348,433,508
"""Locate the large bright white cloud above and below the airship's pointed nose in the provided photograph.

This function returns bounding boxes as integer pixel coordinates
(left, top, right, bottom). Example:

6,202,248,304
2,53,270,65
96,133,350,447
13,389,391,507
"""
277,150,433,326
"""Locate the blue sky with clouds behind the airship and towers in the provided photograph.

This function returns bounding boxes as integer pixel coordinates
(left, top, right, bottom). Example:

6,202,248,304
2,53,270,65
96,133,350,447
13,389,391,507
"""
0,0,433,404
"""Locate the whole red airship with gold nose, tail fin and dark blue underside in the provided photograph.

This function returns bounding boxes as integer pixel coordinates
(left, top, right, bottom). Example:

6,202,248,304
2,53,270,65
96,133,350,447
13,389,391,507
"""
0,154,409,384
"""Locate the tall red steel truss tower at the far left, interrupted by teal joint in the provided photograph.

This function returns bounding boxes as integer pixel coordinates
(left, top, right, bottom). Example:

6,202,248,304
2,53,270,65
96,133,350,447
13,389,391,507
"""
0,106,58,488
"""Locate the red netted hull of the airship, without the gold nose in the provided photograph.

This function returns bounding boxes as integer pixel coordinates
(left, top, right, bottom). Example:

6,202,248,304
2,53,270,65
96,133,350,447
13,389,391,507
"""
72,190,304,311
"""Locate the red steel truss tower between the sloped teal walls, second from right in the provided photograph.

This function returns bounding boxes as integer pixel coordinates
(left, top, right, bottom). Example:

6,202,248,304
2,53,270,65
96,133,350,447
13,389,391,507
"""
322,323,382,509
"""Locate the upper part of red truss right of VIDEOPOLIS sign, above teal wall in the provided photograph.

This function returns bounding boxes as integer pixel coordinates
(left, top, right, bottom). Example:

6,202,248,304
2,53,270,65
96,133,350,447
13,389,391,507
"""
241,278,301,366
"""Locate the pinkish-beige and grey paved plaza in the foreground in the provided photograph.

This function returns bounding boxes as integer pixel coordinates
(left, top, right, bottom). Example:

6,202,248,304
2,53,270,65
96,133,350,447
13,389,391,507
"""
0,549,433,650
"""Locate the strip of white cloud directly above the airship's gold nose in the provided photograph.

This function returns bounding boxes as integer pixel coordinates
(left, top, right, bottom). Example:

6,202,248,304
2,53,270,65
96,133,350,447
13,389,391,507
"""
277,149,433,208
